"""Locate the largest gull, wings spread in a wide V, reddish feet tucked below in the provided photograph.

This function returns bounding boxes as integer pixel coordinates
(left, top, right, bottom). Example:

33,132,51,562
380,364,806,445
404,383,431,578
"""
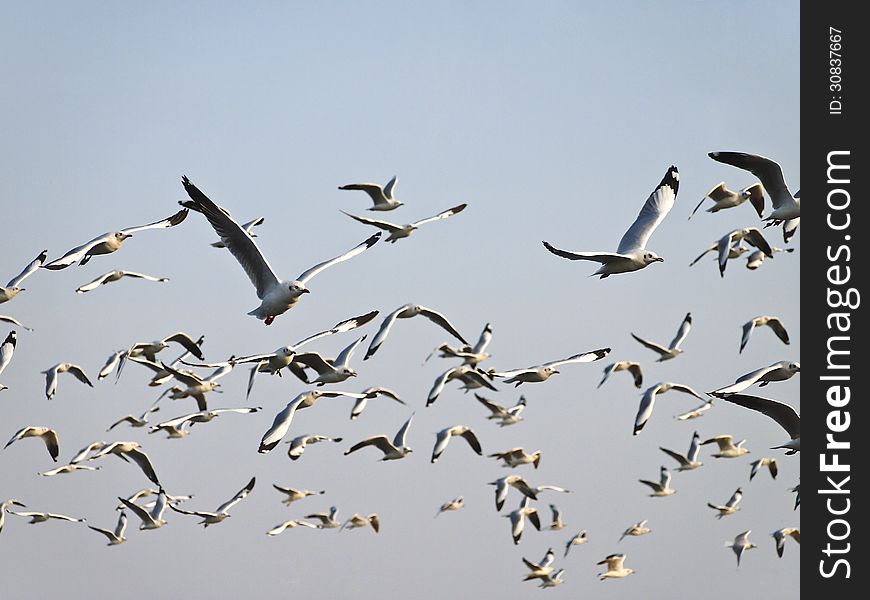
181,176,381,325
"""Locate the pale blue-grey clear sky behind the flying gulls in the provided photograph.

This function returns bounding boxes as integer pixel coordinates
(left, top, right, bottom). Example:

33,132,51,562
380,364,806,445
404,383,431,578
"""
0,1,801,600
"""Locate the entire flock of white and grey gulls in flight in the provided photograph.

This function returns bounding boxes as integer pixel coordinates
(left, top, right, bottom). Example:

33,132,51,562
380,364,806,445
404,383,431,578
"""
0,152,800,588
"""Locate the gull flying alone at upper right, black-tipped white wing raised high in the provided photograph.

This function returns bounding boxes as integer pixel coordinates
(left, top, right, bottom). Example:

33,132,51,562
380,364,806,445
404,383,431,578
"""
543,165,680,279
